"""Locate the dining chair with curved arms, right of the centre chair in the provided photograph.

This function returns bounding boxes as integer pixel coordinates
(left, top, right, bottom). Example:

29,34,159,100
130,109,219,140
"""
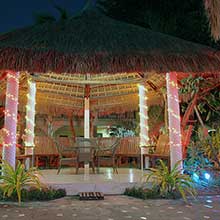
96,138,121,174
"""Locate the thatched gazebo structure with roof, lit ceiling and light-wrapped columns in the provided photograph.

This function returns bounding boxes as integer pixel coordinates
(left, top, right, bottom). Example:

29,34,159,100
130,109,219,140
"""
0,9,220,172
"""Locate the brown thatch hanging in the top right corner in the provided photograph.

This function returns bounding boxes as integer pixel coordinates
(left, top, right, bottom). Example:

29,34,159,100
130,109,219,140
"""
204,0,220,41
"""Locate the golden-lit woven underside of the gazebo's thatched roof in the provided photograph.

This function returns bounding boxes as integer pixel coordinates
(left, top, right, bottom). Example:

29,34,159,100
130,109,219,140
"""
0,72,165,115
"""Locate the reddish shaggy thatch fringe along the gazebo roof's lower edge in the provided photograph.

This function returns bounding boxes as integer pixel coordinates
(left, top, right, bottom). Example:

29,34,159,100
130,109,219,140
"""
0,48,220,74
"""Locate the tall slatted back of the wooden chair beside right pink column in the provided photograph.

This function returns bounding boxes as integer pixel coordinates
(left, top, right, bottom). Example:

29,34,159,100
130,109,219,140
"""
155,134,170,155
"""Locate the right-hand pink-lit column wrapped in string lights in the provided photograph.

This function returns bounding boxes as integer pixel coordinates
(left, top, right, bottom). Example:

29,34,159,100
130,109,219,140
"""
166,72,183,170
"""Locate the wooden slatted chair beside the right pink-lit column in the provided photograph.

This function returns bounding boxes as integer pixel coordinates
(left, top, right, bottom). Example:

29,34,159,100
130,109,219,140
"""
144,134,170,167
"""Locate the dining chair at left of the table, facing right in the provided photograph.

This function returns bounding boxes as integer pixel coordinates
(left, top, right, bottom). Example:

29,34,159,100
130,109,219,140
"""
54,139,78,174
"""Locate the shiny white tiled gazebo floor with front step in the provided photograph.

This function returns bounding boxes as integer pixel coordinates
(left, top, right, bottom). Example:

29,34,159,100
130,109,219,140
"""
40,168,147,195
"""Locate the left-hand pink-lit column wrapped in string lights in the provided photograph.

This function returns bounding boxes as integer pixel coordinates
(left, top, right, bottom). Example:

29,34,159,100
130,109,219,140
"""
2,72,19,168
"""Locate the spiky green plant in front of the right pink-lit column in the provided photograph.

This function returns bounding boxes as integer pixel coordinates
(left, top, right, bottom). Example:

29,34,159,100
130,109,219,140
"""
146,160,196,201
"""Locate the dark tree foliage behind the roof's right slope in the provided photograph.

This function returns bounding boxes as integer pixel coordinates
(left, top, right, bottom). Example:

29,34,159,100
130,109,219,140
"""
97,0,218,47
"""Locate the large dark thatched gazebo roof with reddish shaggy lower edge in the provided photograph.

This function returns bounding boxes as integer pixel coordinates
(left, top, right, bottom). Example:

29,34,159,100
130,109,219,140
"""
0,10,220,74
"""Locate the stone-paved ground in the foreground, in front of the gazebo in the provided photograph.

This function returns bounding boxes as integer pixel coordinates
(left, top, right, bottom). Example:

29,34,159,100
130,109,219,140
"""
0,196,220,220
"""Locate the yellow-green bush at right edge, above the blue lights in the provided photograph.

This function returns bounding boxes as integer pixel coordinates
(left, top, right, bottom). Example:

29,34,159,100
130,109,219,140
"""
204,129,220,169
